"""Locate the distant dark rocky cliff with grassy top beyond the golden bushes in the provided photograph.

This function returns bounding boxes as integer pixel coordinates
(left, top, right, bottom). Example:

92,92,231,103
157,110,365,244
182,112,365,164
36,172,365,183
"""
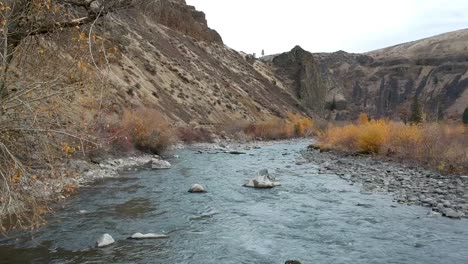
272,30,468,119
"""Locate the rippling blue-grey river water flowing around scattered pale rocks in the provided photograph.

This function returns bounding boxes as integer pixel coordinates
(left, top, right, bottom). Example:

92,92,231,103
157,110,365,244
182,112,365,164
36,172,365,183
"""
0,140,468,264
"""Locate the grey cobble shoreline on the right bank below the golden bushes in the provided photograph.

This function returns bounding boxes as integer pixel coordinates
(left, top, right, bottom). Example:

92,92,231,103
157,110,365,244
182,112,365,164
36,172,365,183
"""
303,146,468,219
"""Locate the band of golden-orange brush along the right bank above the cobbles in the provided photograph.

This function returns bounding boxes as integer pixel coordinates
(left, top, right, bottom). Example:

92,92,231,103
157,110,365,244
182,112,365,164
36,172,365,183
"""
319,118,468,172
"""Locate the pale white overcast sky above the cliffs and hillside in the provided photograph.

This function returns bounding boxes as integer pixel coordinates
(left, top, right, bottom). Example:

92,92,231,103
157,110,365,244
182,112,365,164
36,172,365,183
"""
186,0,468,54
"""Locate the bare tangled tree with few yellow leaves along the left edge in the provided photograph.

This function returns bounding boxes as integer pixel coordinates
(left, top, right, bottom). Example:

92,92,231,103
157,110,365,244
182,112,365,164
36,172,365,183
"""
0,0,135,232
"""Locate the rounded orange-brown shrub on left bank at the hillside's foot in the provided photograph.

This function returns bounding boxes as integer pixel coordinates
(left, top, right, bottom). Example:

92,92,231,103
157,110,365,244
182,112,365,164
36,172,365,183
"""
119,108,175,154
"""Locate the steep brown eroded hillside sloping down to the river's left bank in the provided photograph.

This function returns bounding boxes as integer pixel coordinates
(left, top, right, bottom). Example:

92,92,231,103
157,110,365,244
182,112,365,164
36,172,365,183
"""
6,0,305,129
